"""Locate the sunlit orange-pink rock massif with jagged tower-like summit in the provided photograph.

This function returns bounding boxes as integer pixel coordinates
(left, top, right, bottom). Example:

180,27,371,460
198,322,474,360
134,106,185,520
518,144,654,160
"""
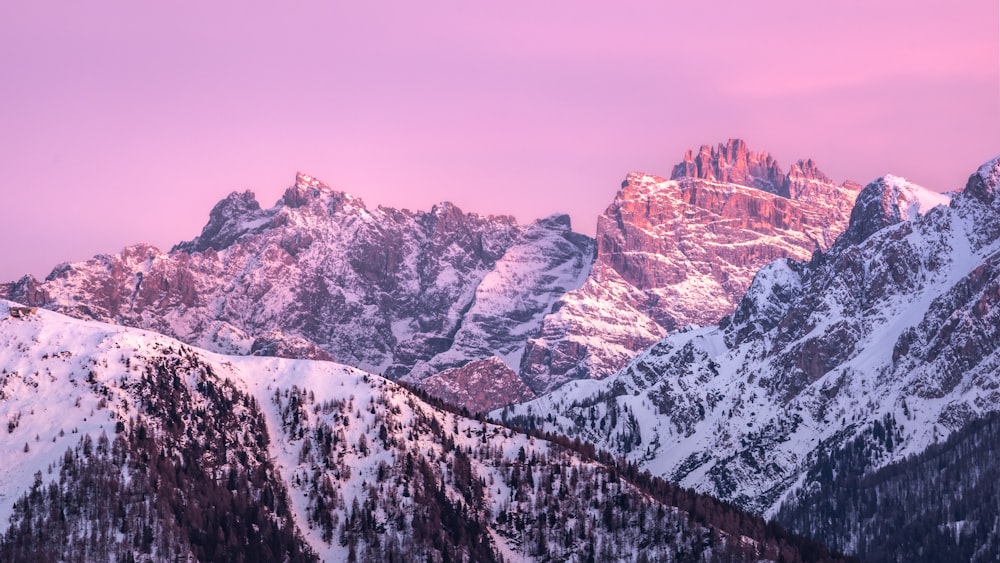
521,140,860,392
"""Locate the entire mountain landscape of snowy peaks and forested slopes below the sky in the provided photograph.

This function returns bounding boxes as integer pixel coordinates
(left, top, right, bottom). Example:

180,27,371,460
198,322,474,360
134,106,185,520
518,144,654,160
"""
0,140,1000,561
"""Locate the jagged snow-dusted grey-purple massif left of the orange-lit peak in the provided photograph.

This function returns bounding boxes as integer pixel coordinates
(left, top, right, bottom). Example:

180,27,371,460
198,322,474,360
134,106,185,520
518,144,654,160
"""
0,174,593,392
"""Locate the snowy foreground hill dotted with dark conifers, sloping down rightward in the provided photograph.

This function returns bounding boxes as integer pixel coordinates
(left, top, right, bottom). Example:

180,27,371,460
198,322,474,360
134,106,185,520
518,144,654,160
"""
0,301,844,561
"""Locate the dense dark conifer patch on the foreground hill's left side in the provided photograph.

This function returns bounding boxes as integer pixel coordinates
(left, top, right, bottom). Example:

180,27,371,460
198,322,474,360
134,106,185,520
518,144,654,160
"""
0,347,314,562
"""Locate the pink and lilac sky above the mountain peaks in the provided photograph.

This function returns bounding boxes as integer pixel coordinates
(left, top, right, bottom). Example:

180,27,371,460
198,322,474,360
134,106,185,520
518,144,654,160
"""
0,0,1000,281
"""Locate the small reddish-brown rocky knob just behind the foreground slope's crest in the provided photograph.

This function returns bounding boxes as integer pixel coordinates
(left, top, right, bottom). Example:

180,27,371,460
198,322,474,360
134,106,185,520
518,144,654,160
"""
420,356,535,413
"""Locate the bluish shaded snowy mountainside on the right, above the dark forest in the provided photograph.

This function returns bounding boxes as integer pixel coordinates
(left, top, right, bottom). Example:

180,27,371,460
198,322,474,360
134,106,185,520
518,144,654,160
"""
504,159,1000,514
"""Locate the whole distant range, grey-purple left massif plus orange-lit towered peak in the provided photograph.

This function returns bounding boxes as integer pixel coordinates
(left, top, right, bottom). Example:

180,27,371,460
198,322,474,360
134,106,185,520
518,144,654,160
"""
0,140,857,411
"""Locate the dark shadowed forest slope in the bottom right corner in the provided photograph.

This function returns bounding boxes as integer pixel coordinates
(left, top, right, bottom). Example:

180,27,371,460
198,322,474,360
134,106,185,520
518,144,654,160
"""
777,413,1000,562
